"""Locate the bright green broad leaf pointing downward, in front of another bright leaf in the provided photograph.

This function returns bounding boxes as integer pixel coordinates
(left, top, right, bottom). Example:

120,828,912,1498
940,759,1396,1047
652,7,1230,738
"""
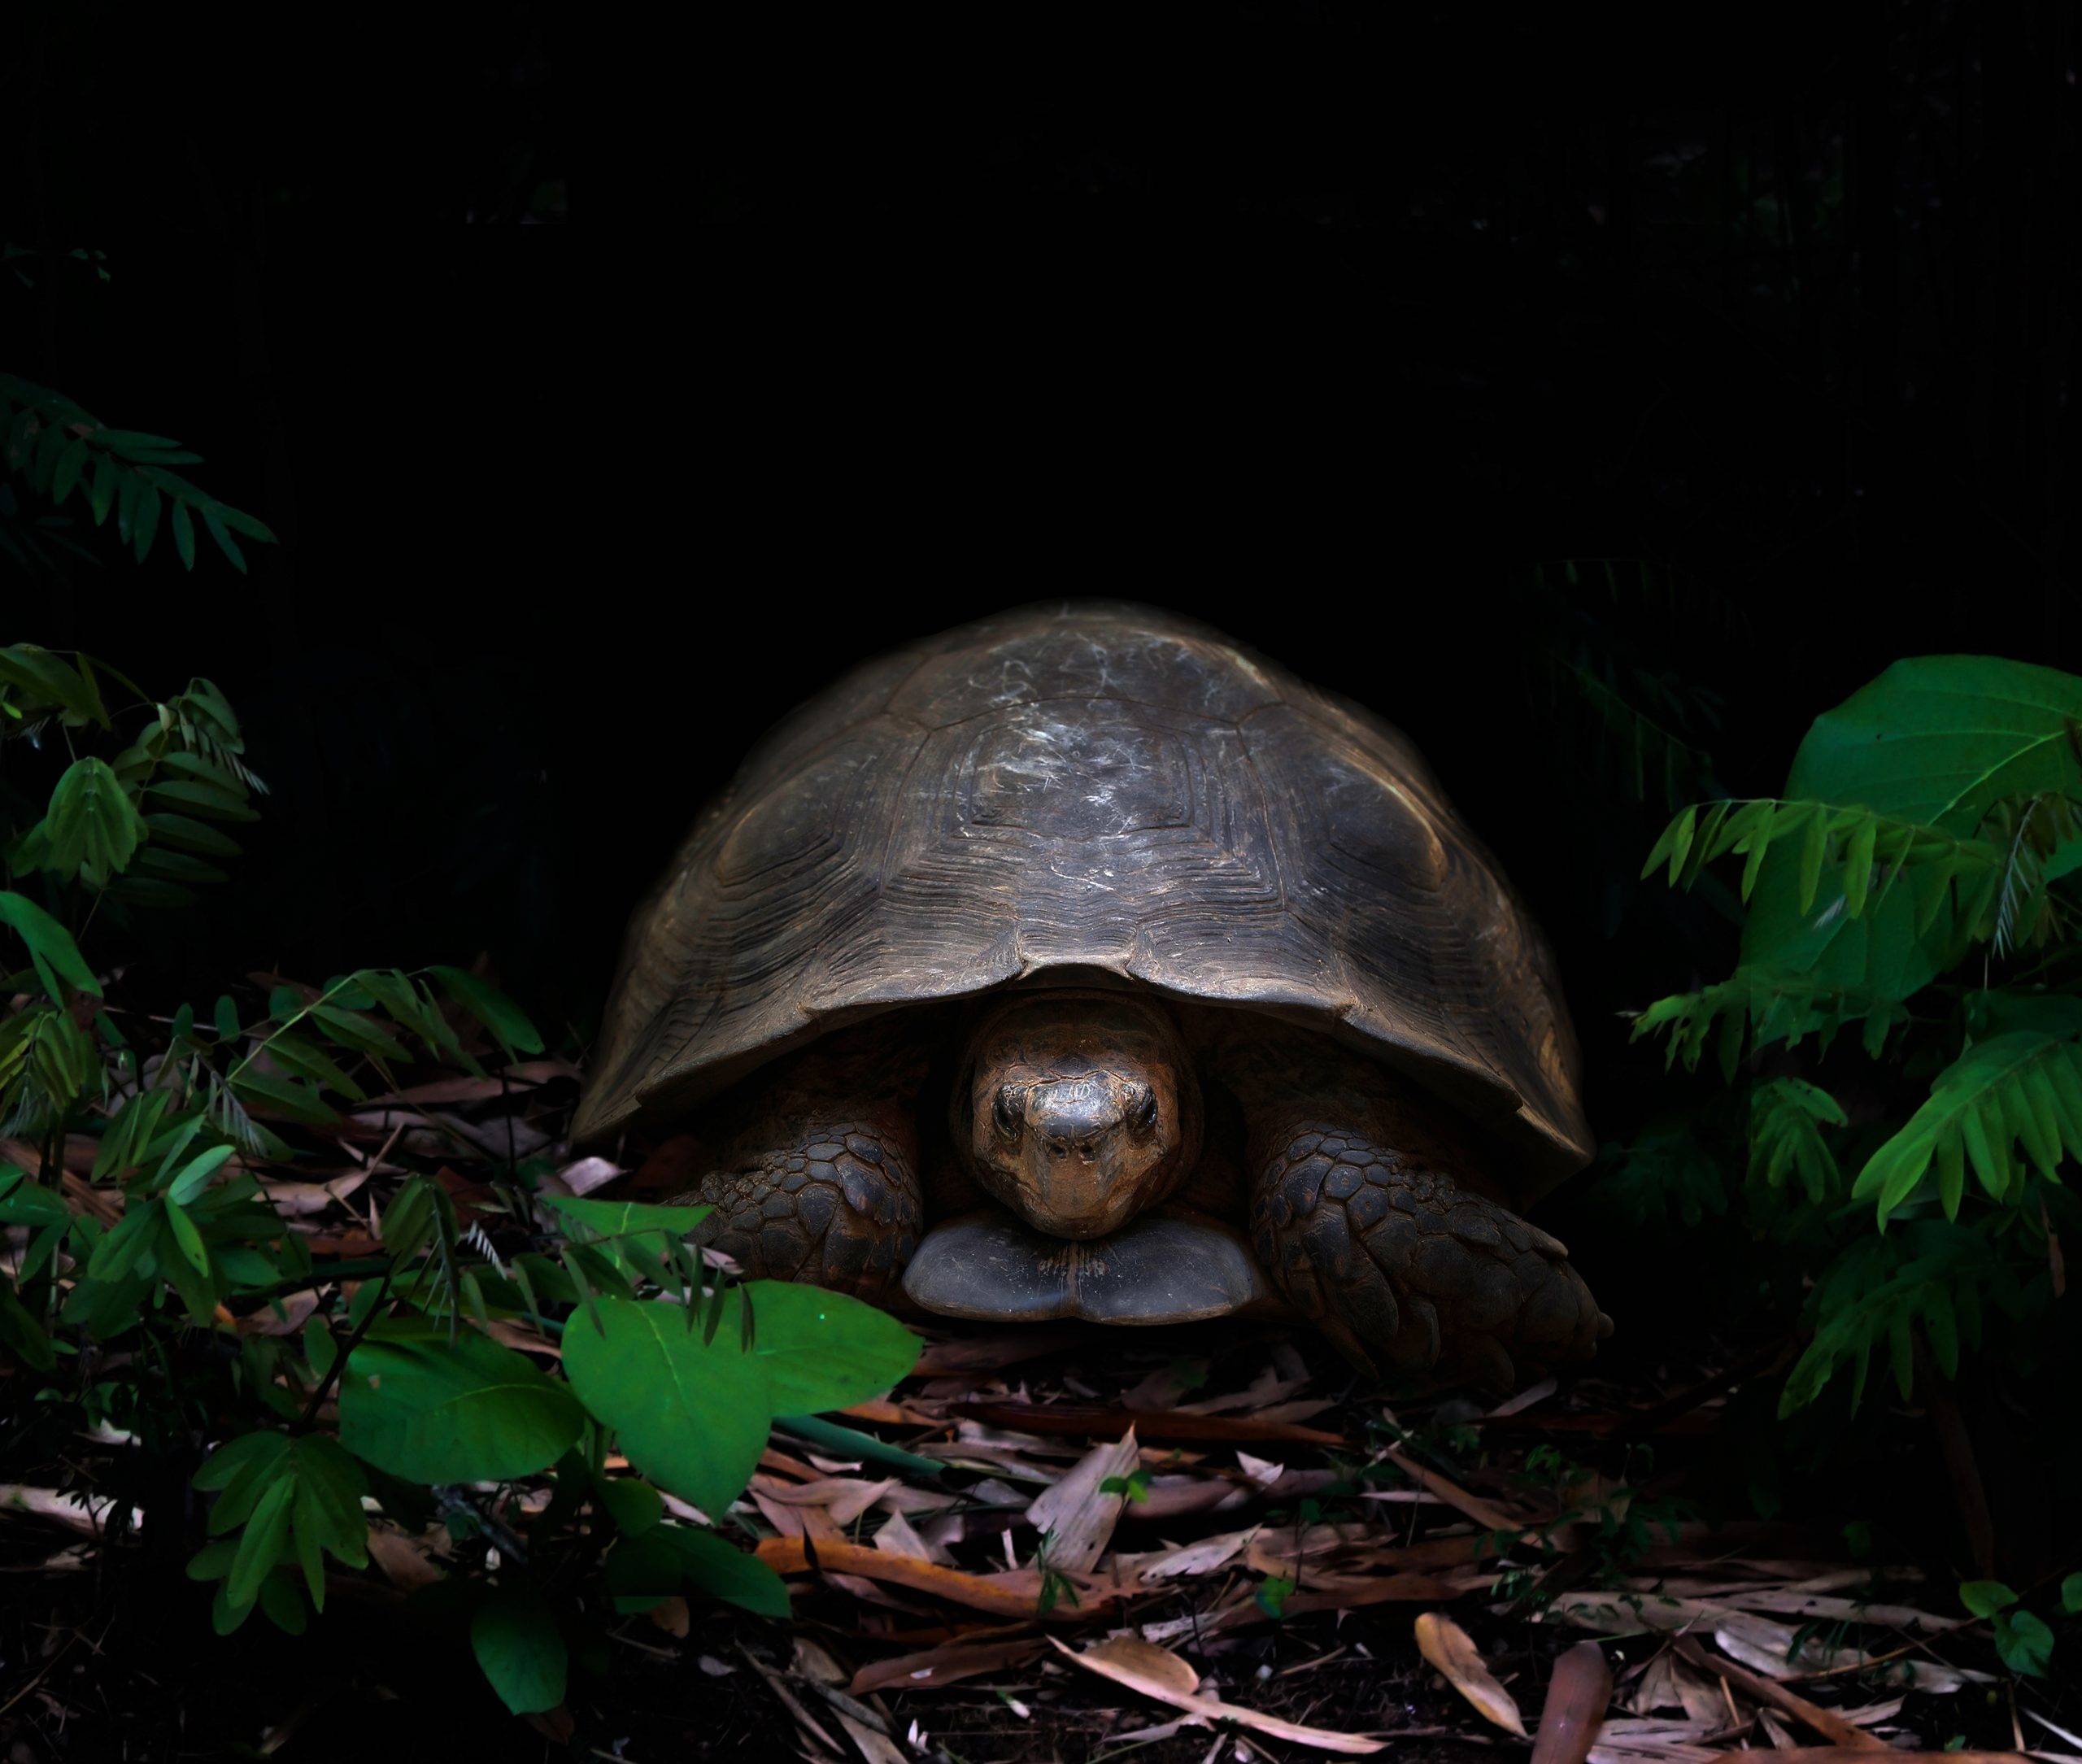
564,1297,773,1518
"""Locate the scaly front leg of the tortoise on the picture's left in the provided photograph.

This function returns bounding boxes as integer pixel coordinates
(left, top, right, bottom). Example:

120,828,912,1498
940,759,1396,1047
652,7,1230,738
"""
679,1029,922,1302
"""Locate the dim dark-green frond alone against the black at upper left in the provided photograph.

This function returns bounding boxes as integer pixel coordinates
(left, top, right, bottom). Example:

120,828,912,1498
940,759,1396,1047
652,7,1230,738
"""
0,372,275,573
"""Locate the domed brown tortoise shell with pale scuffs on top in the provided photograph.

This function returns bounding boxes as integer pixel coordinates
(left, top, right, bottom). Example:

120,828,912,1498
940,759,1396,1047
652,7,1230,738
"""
575,602,1591,1204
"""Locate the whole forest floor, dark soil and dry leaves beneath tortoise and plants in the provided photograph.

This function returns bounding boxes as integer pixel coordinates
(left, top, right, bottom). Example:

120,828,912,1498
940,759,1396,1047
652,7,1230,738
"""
0,1062,2082,1764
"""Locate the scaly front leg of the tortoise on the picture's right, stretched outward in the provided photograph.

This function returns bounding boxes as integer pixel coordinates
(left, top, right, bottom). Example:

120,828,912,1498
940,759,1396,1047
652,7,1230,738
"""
1241,1033,1611,1392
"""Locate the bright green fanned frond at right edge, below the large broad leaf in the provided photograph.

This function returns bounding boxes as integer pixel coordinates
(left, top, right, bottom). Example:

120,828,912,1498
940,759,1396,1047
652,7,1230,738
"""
1851,1029,2082,1226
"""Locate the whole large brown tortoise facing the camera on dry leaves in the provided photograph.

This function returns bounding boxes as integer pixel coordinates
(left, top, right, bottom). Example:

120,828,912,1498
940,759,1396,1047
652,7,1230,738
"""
575,602,1611,1387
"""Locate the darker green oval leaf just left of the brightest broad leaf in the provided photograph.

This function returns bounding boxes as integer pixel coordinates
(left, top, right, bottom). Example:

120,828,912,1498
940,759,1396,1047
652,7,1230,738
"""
339,1318,586,1483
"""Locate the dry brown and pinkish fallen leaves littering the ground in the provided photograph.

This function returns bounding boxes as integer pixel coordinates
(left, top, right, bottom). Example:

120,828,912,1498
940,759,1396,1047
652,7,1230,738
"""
0,1041,2082,1764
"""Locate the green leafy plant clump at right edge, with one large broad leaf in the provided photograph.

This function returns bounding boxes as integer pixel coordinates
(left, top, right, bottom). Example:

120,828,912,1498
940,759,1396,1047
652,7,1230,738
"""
1622,656,2082,1414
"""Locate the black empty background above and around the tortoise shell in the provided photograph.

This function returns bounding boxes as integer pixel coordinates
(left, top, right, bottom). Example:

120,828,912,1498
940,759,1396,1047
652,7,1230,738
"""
16,0,2082,1133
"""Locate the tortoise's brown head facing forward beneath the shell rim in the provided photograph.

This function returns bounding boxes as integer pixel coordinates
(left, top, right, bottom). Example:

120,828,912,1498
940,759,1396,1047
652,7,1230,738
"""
952,991,1200,1237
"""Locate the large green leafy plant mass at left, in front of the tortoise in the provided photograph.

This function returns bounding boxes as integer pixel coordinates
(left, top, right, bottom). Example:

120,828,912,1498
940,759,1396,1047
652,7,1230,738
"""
0,643,920,1712
